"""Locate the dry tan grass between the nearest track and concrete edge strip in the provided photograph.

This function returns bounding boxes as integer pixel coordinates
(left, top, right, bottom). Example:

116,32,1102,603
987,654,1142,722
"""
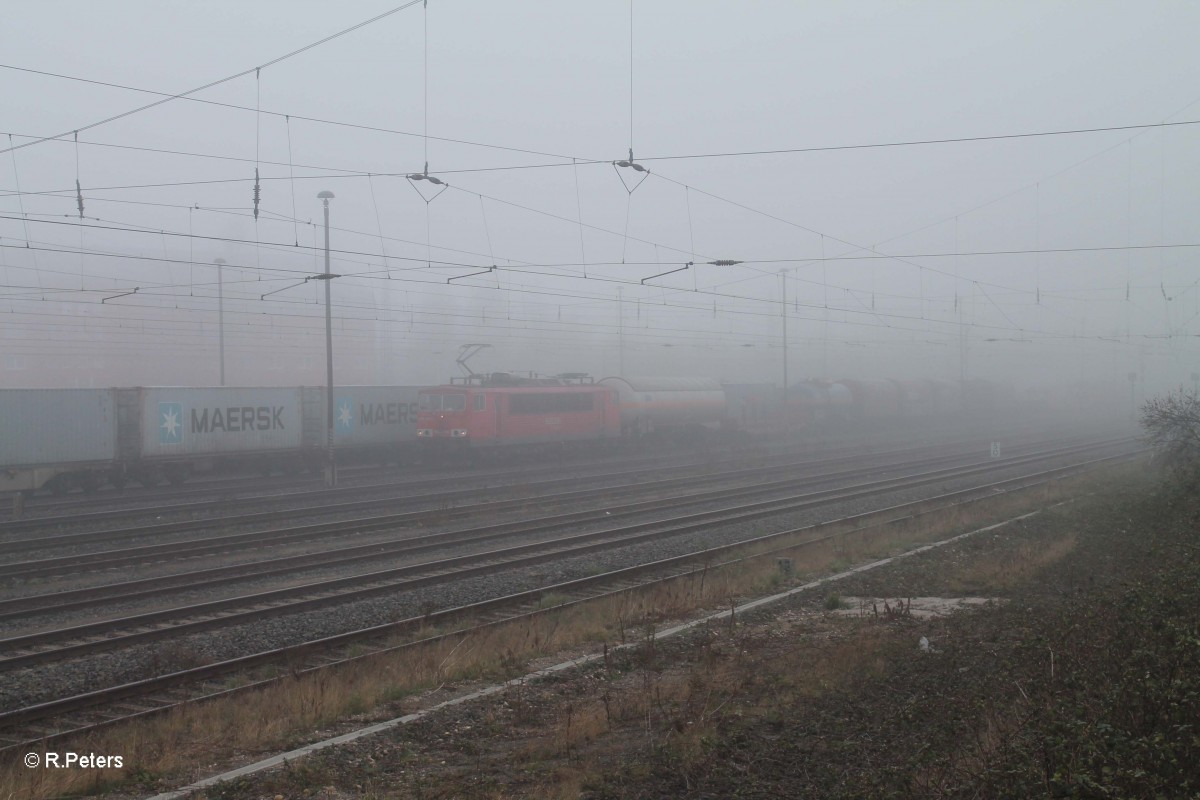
0,470,1123,800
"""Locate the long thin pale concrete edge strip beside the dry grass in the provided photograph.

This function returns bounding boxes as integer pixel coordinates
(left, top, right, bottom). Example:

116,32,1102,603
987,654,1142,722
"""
150,503,1046,800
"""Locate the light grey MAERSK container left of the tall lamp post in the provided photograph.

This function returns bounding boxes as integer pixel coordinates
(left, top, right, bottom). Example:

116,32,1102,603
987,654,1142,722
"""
132,386,302,459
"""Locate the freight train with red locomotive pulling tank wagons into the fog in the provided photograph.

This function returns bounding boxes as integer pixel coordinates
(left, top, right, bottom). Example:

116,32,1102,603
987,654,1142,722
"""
416,373,1001,451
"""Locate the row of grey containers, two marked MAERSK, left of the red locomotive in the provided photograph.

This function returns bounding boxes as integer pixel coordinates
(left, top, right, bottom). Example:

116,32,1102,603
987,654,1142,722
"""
0,386,419,493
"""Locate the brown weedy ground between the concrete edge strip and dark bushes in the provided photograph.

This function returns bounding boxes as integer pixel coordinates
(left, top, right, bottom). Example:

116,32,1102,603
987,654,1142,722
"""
93,455,1171,800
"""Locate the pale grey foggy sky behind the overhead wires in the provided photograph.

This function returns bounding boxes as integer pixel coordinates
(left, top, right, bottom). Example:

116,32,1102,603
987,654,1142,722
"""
0,0,1200,412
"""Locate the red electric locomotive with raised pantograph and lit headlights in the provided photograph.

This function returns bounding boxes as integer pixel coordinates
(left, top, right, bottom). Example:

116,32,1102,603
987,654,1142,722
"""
416,373,620,450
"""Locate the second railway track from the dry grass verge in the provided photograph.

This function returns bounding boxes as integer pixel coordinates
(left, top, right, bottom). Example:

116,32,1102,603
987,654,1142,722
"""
0,443,1123,672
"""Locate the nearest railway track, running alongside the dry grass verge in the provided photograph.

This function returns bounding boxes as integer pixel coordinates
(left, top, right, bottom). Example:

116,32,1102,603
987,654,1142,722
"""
0,455,1130,752
